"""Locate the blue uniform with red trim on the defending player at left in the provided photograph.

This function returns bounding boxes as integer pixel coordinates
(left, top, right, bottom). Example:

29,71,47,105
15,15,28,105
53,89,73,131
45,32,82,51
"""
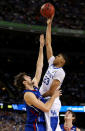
24,87,46,131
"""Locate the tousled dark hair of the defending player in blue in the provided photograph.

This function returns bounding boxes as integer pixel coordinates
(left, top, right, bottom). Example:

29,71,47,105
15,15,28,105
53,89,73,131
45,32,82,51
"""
14,72,27,91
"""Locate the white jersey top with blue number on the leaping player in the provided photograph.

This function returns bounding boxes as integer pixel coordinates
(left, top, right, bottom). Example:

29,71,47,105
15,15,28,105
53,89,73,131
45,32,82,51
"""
40,56,65,95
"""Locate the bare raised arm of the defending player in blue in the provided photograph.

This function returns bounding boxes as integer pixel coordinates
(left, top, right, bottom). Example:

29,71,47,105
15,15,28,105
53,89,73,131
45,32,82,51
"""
33,34,44,86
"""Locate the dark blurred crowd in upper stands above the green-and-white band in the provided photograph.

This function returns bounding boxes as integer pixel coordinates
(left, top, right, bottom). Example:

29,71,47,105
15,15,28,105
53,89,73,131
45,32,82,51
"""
0,0,85,29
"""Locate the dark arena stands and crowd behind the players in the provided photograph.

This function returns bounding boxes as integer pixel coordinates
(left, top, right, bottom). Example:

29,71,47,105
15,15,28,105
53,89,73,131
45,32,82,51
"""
0,0,85,131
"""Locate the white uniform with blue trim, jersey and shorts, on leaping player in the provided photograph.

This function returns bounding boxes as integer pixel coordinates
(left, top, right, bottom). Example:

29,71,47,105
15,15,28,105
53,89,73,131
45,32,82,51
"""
40,56,65,131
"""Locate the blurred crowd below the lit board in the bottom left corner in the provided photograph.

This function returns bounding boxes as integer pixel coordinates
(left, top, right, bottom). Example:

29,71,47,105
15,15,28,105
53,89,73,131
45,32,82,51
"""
0,111,25,131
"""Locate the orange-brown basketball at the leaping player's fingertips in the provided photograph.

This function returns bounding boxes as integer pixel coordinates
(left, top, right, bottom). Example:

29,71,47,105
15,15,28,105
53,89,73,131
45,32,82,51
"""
40,3,55,18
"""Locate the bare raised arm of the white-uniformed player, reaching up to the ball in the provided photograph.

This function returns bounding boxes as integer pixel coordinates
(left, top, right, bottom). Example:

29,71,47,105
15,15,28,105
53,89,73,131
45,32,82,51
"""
46,18,53,60
